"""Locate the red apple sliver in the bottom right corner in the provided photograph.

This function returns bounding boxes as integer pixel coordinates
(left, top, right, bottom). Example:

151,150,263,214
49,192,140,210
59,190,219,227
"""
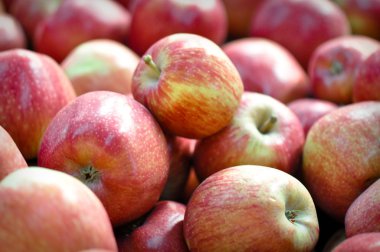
332,232,380,252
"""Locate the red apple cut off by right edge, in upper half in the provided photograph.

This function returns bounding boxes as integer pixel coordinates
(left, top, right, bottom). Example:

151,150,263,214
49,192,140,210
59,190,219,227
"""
352,49,380,102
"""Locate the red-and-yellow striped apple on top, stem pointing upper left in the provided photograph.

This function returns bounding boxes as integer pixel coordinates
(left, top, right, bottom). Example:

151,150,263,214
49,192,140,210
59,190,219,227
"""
132,33,244,138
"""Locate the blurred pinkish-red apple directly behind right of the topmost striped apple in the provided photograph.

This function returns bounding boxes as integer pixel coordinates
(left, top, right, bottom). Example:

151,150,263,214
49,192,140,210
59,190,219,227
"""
222,38,309,103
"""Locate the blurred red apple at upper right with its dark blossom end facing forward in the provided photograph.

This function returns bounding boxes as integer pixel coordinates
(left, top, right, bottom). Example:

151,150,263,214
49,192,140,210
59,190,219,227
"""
308,35,380,104
